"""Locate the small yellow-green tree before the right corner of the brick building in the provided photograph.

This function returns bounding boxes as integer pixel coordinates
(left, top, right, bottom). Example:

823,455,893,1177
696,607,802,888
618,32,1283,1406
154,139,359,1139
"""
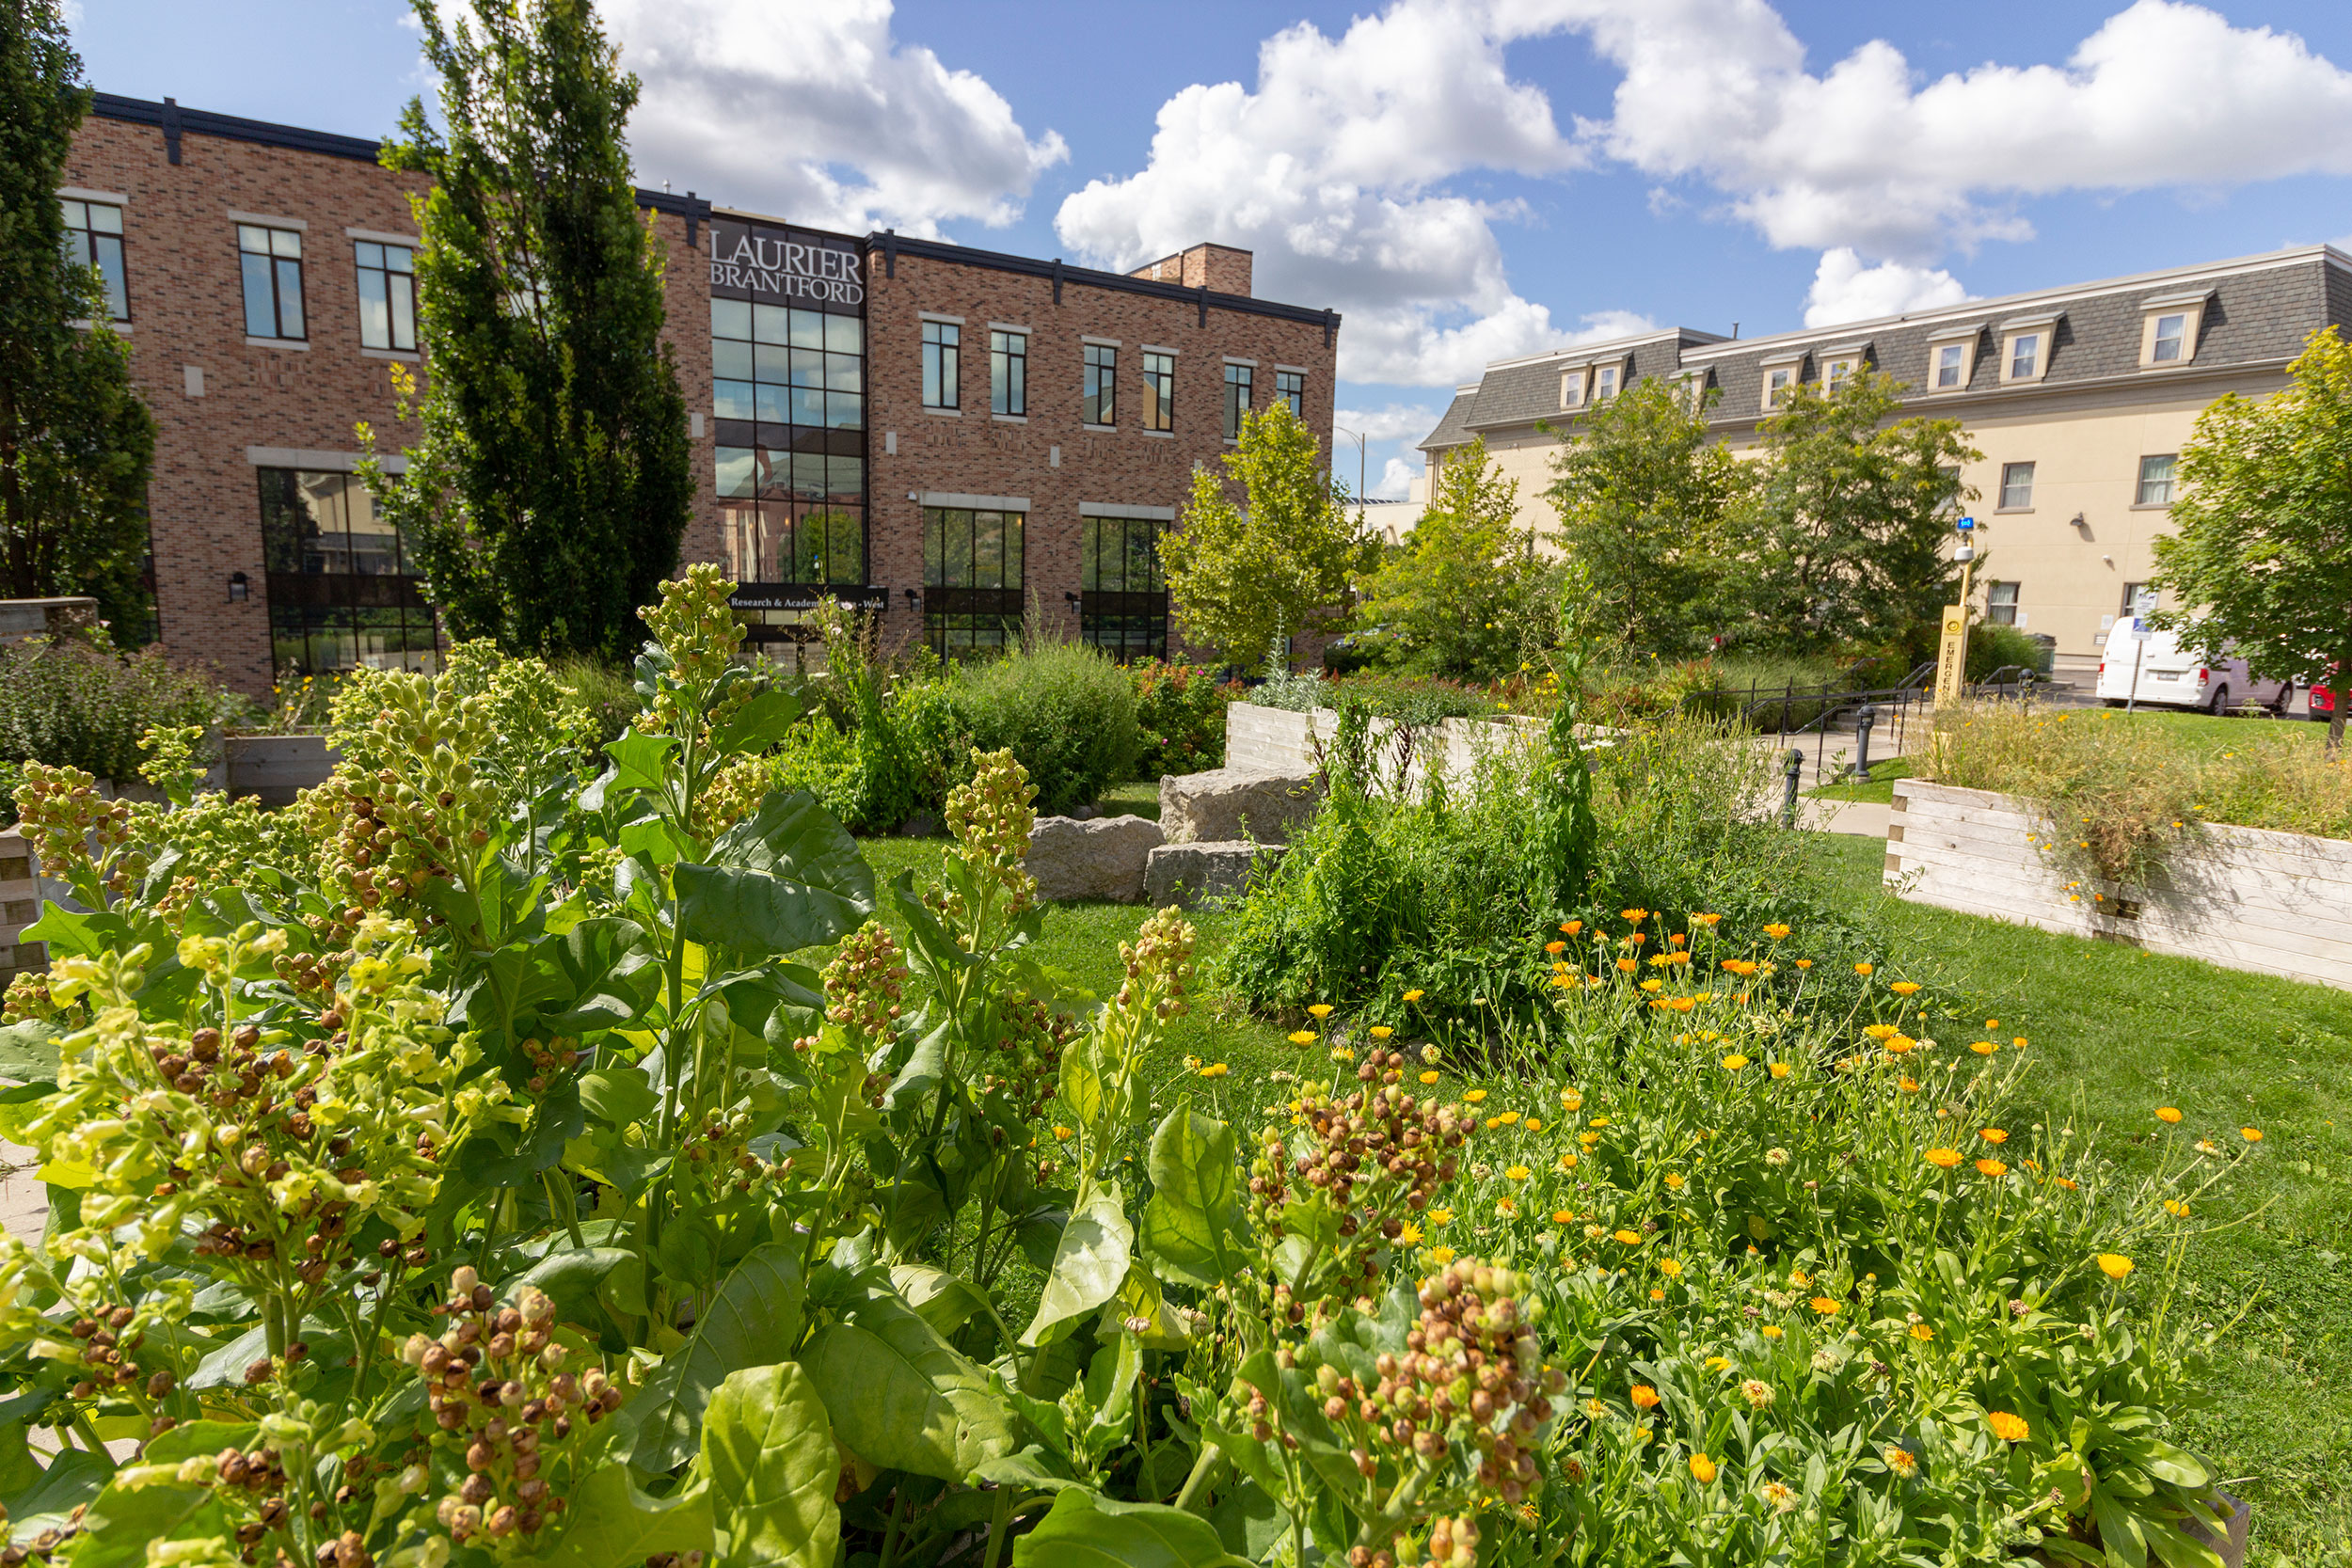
1160,402,1372,670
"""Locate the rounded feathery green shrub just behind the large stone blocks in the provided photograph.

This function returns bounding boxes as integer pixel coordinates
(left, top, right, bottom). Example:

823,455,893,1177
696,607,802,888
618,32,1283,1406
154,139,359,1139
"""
955,641,1143,816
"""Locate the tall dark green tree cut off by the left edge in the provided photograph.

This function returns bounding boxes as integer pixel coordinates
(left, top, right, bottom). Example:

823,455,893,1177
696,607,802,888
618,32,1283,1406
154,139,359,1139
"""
0,0,155,640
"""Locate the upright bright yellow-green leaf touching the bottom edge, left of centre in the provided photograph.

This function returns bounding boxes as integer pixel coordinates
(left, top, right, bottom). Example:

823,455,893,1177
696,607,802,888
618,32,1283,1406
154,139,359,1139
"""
704,1364,842,1568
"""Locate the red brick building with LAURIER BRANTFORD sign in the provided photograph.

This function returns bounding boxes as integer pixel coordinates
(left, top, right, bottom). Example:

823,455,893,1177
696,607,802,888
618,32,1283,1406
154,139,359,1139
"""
59,94,1339,693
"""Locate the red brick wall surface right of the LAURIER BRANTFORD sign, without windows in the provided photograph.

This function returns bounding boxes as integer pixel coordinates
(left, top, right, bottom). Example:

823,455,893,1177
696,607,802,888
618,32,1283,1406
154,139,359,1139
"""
866,246,1339,657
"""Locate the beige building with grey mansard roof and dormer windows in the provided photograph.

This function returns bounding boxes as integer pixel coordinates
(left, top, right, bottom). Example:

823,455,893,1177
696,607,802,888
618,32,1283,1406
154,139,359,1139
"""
1416,245,2352,663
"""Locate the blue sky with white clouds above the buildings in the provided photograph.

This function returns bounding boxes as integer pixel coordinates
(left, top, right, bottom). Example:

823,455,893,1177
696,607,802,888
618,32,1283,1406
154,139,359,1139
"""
75,0,2352,489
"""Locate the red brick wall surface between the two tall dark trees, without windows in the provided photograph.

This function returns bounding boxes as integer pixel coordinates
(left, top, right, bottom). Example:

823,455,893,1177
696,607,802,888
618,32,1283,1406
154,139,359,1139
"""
66,115,423,696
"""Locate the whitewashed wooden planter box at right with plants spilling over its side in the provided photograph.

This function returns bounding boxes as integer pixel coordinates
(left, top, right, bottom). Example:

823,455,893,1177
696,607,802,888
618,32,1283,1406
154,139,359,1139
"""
1886,778,2352,990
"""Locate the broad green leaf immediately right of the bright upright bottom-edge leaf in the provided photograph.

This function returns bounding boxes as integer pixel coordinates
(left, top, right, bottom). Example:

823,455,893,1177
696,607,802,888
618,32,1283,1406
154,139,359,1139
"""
800,1293,1016,1481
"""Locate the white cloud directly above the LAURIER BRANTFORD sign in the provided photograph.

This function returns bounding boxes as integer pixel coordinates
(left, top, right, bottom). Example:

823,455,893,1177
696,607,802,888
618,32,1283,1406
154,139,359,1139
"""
605,0,1068,235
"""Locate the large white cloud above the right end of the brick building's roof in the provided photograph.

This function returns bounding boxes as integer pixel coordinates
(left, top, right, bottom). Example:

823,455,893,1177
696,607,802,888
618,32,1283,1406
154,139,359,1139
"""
1057,0,1588,386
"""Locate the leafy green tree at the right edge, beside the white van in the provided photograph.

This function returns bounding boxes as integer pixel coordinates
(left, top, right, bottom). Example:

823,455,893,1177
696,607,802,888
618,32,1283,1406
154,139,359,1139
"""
2150,326,2352,752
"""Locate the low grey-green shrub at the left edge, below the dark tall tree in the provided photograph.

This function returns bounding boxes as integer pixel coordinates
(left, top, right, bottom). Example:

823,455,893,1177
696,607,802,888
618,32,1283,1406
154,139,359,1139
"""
0,640,249,783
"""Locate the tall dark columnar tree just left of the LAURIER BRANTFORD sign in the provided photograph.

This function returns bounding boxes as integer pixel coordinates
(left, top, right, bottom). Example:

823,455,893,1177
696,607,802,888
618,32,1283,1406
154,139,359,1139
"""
372,0,694,658
